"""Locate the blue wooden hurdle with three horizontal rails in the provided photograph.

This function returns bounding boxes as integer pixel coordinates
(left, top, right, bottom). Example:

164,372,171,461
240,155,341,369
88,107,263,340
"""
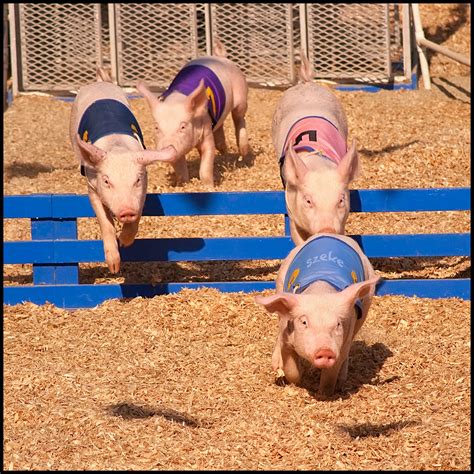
4,188,470,308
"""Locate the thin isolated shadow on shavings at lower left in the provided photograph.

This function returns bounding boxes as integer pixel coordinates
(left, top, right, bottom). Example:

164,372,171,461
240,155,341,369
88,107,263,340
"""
105,402,209,428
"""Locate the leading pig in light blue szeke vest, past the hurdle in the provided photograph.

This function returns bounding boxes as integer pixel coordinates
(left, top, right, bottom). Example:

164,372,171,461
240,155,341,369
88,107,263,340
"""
255,233,379,397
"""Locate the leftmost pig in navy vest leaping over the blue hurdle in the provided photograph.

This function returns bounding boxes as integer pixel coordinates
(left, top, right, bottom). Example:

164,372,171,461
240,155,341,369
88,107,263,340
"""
69,68,179,273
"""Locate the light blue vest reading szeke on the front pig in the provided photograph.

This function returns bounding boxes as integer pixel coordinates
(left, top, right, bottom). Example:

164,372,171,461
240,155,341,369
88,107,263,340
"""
283,236,366,319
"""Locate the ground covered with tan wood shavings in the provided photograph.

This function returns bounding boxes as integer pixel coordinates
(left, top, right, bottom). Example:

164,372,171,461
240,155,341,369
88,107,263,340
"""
3,4,471,470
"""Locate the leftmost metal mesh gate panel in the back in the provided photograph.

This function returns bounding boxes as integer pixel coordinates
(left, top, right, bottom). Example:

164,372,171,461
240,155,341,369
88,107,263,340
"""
9,3,102,91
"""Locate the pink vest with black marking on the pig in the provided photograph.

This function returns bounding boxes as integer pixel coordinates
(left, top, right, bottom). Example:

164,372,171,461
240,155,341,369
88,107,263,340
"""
280,115,347,186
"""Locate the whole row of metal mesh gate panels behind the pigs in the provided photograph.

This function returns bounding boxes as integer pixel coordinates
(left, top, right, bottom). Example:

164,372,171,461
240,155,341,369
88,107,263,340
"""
9,3,412,94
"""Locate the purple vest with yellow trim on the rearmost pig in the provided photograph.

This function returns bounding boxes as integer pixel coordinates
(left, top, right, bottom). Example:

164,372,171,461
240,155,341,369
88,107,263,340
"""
161,64,225,128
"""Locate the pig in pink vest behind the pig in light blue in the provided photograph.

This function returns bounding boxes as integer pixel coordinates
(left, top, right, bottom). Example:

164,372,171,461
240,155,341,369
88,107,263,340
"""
272,53,360,245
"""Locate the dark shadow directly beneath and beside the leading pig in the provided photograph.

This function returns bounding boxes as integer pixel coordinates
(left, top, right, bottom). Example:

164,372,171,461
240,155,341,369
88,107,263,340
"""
292,341,400,400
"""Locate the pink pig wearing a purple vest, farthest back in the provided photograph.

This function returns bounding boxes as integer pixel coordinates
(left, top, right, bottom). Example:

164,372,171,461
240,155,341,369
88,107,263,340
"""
136,38,249,187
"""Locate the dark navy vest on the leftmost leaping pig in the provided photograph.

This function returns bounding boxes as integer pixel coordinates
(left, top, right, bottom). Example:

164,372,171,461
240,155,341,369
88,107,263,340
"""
78,99,145,176
